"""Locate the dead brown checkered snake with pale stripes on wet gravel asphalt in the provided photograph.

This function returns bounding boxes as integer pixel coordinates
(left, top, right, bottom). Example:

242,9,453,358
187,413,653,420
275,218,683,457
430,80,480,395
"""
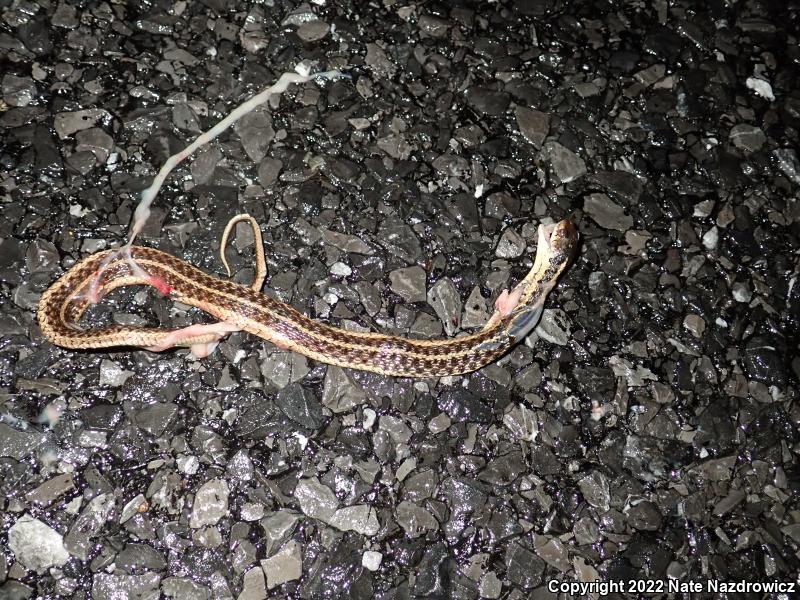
37,215,578,377
